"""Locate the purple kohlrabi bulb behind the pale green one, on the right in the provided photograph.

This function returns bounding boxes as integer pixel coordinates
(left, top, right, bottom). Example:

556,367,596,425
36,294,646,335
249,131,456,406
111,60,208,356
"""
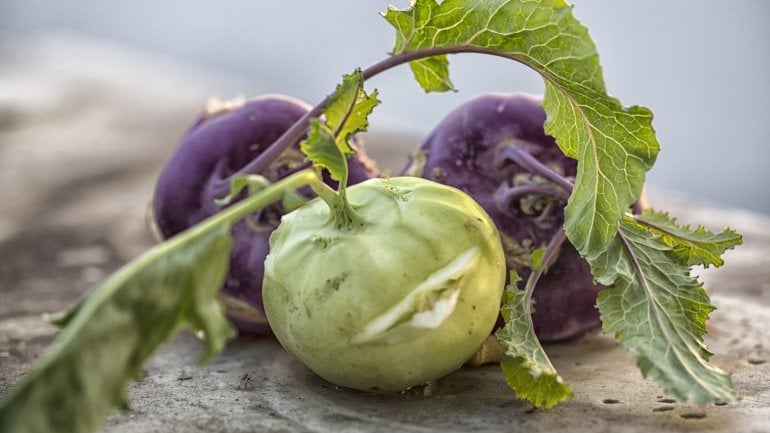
404,94,602,342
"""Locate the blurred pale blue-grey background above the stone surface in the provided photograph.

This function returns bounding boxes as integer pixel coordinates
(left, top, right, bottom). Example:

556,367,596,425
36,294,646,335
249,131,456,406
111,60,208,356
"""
0,0,770,213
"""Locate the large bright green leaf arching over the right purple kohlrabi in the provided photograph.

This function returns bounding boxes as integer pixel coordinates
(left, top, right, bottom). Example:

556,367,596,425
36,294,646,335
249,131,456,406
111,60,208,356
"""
385,0,658,258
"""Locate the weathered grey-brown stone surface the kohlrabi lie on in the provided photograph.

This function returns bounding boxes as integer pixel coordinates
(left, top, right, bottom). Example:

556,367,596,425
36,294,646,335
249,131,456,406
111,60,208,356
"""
0,36,770,433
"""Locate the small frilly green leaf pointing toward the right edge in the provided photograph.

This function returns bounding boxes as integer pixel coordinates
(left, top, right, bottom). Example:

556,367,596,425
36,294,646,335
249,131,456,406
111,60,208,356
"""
635,209,743,267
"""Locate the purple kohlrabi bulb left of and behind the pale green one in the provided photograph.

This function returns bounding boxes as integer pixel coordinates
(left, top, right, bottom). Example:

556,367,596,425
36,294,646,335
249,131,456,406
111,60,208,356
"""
153,95,377,334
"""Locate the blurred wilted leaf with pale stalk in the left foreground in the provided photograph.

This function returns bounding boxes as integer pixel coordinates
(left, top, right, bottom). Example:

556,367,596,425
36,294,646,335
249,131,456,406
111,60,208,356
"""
0,170,323,433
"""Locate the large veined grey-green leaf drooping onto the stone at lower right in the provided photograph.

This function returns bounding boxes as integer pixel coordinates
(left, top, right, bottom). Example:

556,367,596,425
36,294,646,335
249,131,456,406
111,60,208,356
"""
591,217,736,404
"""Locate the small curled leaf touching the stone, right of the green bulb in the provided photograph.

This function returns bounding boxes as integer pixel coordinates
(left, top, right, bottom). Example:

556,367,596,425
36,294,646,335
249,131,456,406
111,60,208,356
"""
495,271,572,409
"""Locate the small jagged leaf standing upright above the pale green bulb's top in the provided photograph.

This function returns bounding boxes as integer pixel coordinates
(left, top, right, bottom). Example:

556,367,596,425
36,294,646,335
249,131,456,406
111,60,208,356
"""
300,69,380,184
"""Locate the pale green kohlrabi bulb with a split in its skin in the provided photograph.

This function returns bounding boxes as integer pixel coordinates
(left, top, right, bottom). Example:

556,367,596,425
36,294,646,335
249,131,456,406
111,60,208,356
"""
262,177,506,392
